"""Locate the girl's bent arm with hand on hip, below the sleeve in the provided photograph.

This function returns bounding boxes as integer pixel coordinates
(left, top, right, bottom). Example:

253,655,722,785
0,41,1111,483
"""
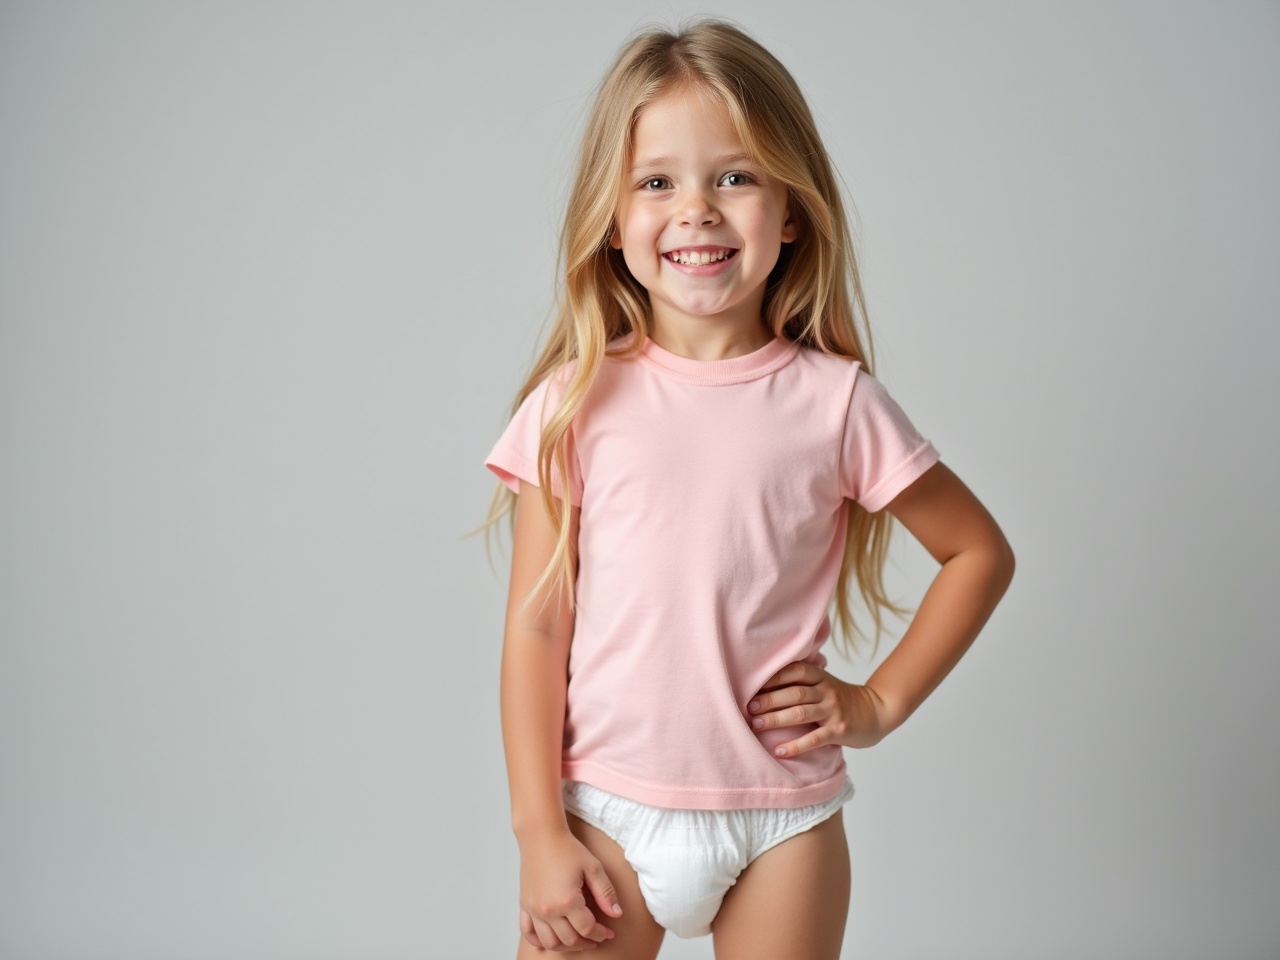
751,462,1014,756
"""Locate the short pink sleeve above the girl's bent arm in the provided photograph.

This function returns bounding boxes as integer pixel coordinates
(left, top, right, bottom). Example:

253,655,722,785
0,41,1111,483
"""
840,366,940,513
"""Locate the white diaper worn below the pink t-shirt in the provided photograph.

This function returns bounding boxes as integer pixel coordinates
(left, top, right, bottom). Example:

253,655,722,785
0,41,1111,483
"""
561,777,854,938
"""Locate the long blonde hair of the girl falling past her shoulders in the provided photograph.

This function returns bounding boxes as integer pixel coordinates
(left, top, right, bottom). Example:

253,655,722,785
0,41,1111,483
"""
483,19,906,654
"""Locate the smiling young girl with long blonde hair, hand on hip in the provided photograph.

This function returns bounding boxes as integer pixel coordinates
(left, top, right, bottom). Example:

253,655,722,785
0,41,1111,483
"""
485,20,1014,960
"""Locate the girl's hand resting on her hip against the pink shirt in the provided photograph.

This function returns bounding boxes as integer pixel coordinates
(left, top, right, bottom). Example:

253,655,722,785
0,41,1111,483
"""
748,660,892,758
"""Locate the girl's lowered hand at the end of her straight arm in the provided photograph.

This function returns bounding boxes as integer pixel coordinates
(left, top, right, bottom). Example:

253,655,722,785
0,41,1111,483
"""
520,828,622,954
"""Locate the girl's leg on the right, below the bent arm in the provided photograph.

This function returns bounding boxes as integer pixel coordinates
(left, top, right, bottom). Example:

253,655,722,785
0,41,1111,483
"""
712,810,850,960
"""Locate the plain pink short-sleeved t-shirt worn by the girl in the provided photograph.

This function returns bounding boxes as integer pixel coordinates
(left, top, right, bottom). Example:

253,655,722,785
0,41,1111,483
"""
485,334,938,810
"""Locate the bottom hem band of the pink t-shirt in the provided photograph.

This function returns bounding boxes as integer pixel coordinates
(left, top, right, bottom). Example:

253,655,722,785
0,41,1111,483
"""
561,758,849,810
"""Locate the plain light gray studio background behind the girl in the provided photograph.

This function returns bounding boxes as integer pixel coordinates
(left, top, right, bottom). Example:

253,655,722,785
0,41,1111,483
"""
0,1,1280,960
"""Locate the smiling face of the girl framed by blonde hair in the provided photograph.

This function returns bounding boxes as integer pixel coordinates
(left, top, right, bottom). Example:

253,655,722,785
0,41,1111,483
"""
611,87,796,343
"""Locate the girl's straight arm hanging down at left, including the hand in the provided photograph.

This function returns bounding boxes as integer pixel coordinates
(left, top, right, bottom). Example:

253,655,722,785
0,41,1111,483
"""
502,480,621,950
